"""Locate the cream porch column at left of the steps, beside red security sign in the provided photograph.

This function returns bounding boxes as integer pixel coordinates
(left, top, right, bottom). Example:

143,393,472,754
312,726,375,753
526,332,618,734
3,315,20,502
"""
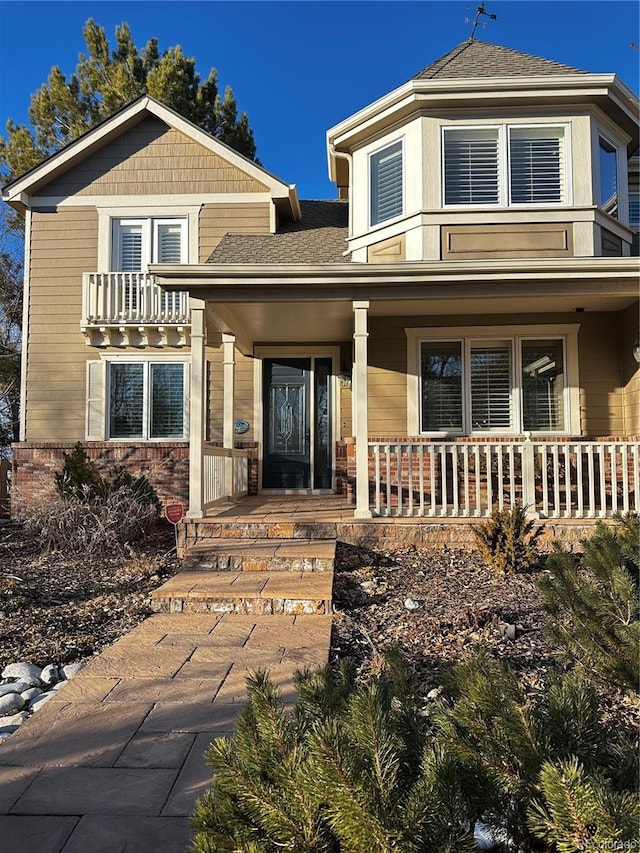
187,299,207,518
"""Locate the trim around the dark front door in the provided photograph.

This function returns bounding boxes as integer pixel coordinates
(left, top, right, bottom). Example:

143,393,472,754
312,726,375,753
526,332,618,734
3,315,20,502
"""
253,345,340,495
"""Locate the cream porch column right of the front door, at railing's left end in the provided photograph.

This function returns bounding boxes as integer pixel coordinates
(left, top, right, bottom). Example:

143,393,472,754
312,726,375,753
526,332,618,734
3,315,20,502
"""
353,301,371,518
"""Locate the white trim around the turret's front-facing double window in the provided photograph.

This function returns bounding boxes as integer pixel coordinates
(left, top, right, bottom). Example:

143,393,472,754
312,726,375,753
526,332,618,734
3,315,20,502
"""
440,122,573,210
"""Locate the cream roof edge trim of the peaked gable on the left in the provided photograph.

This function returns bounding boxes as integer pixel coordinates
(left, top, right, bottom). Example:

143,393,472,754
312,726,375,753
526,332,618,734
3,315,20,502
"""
2,95,299,217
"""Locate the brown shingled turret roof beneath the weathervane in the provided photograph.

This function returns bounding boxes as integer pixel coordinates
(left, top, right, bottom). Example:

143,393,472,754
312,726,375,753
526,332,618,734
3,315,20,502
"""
412,39,587,80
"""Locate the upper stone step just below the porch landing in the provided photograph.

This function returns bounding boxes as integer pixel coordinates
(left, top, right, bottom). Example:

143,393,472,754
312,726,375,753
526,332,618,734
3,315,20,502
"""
183,539,336,572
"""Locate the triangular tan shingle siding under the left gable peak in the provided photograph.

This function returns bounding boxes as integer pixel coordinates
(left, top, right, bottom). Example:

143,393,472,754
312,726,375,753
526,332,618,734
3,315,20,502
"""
38,118,267,197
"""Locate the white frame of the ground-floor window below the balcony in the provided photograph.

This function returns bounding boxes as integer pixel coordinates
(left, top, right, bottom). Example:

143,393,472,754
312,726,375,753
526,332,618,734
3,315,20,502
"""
103,355,190,443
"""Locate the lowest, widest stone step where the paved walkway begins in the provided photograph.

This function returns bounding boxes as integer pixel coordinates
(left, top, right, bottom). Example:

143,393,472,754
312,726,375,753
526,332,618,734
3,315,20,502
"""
152,571,333,615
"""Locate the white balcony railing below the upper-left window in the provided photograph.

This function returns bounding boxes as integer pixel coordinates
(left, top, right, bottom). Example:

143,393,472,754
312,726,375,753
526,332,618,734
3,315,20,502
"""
82,272,189,326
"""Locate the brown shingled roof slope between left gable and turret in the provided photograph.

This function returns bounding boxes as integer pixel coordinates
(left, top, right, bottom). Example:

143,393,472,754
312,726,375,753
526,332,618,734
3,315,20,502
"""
207,200,349,264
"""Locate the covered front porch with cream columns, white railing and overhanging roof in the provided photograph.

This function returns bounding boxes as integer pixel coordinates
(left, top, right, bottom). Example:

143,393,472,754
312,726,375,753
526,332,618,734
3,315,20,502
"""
153,258,640,523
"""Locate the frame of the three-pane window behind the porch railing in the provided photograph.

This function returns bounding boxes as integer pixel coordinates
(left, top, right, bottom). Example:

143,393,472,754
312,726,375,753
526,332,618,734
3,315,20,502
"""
405,324,580,438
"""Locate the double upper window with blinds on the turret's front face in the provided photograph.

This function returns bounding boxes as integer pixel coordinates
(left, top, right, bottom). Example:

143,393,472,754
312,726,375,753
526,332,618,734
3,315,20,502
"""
443,125,568,207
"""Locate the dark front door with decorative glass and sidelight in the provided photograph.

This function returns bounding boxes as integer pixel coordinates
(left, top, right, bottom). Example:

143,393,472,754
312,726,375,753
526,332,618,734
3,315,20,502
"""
262,358,332,490
